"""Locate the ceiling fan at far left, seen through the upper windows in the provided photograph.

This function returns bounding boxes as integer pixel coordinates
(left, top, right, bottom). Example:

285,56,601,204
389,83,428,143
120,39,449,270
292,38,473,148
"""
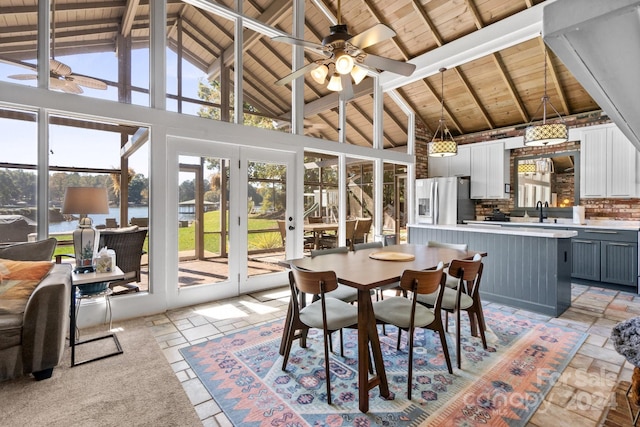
4,0,107,94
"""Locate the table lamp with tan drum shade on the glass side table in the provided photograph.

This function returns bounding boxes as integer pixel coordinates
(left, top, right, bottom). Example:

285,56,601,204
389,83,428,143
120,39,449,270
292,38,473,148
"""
62,187,109,273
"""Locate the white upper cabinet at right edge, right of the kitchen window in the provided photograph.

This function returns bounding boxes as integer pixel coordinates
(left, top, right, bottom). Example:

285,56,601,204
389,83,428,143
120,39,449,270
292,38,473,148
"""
580,125,638,198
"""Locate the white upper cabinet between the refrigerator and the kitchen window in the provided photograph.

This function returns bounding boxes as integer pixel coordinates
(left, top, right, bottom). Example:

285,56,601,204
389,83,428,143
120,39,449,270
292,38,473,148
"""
470,142,509,199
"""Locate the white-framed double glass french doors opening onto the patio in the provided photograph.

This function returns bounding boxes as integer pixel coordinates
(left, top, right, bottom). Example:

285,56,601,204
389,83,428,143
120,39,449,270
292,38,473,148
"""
172,141,297,304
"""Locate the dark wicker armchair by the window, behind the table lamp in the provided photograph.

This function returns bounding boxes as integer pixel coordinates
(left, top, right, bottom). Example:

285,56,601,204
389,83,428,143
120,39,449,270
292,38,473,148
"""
100,229,147,295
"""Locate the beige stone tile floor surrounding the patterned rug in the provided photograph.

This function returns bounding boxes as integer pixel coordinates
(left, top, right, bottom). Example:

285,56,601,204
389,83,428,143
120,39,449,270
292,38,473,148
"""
146,285,640,427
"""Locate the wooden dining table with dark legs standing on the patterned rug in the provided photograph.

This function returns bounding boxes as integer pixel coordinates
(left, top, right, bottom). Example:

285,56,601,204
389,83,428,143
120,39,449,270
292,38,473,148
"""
289,244,486,412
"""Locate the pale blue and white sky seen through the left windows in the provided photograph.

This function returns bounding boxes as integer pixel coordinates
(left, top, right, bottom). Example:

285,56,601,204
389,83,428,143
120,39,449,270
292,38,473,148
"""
0,49,205,176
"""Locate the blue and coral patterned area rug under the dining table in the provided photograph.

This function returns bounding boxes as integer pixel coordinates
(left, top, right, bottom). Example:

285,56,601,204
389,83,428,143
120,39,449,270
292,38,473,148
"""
180,308,586,427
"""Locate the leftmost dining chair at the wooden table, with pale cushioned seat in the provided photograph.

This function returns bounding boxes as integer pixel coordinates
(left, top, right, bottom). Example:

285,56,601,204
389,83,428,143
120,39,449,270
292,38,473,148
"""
282,264,358,405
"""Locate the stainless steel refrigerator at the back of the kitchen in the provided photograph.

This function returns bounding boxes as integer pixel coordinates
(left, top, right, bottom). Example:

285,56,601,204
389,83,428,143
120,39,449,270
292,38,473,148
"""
416,177,476,224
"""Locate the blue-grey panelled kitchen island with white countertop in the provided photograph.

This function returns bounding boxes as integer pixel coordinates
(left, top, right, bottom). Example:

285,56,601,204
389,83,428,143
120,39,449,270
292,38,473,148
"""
407,224,577,316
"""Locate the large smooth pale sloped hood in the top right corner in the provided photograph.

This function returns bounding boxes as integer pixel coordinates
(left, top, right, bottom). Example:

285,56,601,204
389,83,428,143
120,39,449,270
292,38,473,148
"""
542,0,640,150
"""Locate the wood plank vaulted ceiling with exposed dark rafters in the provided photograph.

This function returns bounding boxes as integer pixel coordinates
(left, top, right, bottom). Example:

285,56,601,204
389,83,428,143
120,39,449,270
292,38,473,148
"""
0,0,599,148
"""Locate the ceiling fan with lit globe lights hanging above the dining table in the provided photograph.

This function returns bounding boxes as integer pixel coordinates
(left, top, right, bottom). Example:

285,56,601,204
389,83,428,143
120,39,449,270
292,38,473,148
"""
272,0,416,100
